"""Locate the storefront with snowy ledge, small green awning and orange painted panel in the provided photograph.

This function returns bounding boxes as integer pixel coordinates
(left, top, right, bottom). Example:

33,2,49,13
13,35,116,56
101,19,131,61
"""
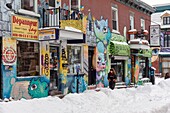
129,39,152,83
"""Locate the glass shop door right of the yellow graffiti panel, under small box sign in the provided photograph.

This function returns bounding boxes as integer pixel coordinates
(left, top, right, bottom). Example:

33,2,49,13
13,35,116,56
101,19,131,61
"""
50,46,59,90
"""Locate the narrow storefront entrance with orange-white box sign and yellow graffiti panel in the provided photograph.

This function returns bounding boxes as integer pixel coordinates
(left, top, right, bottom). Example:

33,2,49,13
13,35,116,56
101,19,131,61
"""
39,28,60,90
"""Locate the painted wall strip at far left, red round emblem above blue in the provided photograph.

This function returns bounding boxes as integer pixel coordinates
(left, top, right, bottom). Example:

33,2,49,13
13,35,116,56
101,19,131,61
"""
1,37,16,98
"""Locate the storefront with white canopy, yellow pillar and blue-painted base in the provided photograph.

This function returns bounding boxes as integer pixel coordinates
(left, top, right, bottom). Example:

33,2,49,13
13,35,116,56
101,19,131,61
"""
59,30,88,94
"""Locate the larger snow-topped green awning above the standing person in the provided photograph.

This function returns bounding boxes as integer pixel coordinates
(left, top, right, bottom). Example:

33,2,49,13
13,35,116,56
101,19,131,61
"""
109,41,130,56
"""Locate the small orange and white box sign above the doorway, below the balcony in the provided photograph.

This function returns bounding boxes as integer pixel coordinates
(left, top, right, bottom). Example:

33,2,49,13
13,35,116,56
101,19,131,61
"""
38,29,59,40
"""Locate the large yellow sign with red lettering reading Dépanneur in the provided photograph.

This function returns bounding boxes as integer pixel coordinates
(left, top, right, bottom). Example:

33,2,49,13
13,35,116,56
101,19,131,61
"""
11,15,38,40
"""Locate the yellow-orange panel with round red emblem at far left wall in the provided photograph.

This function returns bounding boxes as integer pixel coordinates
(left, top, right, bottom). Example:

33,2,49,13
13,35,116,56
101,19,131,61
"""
2,37,17,65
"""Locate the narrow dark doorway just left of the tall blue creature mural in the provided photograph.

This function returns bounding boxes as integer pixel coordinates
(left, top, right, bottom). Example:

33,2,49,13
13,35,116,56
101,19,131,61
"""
88,47,96,85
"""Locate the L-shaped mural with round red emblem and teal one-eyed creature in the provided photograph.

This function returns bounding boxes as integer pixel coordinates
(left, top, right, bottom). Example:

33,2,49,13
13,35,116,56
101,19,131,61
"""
1,37,49,100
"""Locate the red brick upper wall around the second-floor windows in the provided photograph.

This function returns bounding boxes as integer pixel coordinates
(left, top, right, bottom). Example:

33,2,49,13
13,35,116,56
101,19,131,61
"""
62,0,150,36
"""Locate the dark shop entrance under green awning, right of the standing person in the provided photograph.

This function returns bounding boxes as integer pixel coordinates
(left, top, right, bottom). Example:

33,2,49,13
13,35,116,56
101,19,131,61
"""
111,60,125,82
